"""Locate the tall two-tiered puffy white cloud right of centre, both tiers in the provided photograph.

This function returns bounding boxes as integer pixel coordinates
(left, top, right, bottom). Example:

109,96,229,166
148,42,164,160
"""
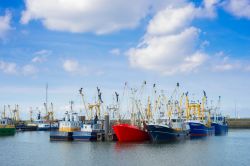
127,1,217,75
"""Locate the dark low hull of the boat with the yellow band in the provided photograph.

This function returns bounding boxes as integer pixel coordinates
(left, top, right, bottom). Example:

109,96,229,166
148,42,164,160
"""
50,131,73,141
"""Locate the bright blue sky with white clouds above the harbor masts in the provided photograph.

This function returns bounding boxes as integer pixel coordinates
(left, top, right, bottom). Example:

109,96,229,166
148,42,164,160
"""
0,0,250,119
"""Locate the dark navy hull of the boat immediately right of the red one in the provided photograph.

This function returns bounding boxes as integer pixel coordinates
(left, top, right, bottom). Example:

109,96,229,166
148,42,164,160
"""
147,125,189,142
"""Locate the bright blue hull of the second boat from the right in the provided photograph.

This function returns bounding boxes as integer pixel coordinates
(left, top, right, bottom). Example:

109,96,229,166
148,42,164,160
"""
188,122,215,137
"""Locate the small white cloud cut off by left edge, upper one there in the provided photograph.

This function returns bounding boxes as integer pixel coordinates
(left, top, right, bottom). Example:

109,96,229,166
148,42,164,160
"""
0,11,11,38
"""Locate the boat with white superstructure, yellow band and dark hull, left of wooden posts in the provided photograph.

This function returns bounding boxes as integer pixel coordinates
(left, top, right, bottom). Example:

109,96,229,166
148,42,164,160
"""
50,110,82,141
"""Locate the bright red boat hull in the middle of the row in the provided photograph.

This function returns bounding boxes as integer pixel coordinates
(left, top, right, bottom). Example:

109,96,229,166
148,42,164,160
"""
113,124,149,142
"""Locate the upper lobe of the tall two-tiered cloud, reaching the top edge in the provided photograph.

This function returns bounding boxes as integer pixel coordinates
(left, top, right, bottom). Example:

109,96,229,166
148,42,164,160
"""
147,0,218,35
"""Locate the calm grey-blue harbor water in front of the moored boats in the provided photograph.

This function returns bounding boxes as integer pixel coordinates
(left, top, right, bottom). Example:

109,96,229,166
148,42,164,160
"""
0,129,250,166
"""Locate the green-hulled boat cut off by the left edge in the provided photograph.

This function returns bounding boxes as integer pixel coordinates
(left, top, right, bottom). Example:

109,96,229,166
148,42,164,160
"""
0,118,16,136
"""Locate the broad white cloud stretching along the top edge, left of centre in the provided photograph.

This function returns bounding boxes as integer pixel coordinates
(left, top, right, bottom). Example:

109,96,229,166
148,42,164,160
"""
21,0,175,34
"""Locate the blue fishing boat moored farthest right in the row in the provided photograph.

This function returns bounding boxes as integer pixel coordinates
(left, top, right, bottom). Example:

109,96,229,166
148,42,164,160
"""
211,114,228,135
